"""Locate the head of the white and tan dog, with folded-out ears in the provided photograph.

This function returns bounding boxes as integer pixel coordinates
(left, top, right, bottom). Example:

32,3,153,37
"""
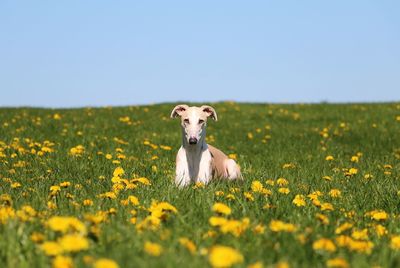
171,104,217,145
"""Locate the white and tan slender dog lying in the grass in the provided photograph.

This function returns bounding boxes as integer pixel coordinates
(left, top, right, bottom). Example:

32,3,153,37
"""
171,104,243,187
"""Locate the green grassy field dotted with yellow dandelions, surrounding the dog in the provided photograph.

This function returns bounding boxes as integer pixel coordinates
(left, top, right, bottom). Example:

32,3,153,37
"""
0,103,400,267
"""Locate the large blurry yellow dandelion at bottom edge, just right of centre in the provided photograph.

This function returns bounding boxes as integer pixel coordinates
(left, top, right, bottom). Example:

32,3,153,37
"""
208,245,243,267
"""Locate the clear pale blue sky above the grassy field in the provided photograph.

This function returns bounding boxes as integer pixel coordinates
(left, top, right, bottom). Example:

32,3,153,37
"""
0,0,400,107
